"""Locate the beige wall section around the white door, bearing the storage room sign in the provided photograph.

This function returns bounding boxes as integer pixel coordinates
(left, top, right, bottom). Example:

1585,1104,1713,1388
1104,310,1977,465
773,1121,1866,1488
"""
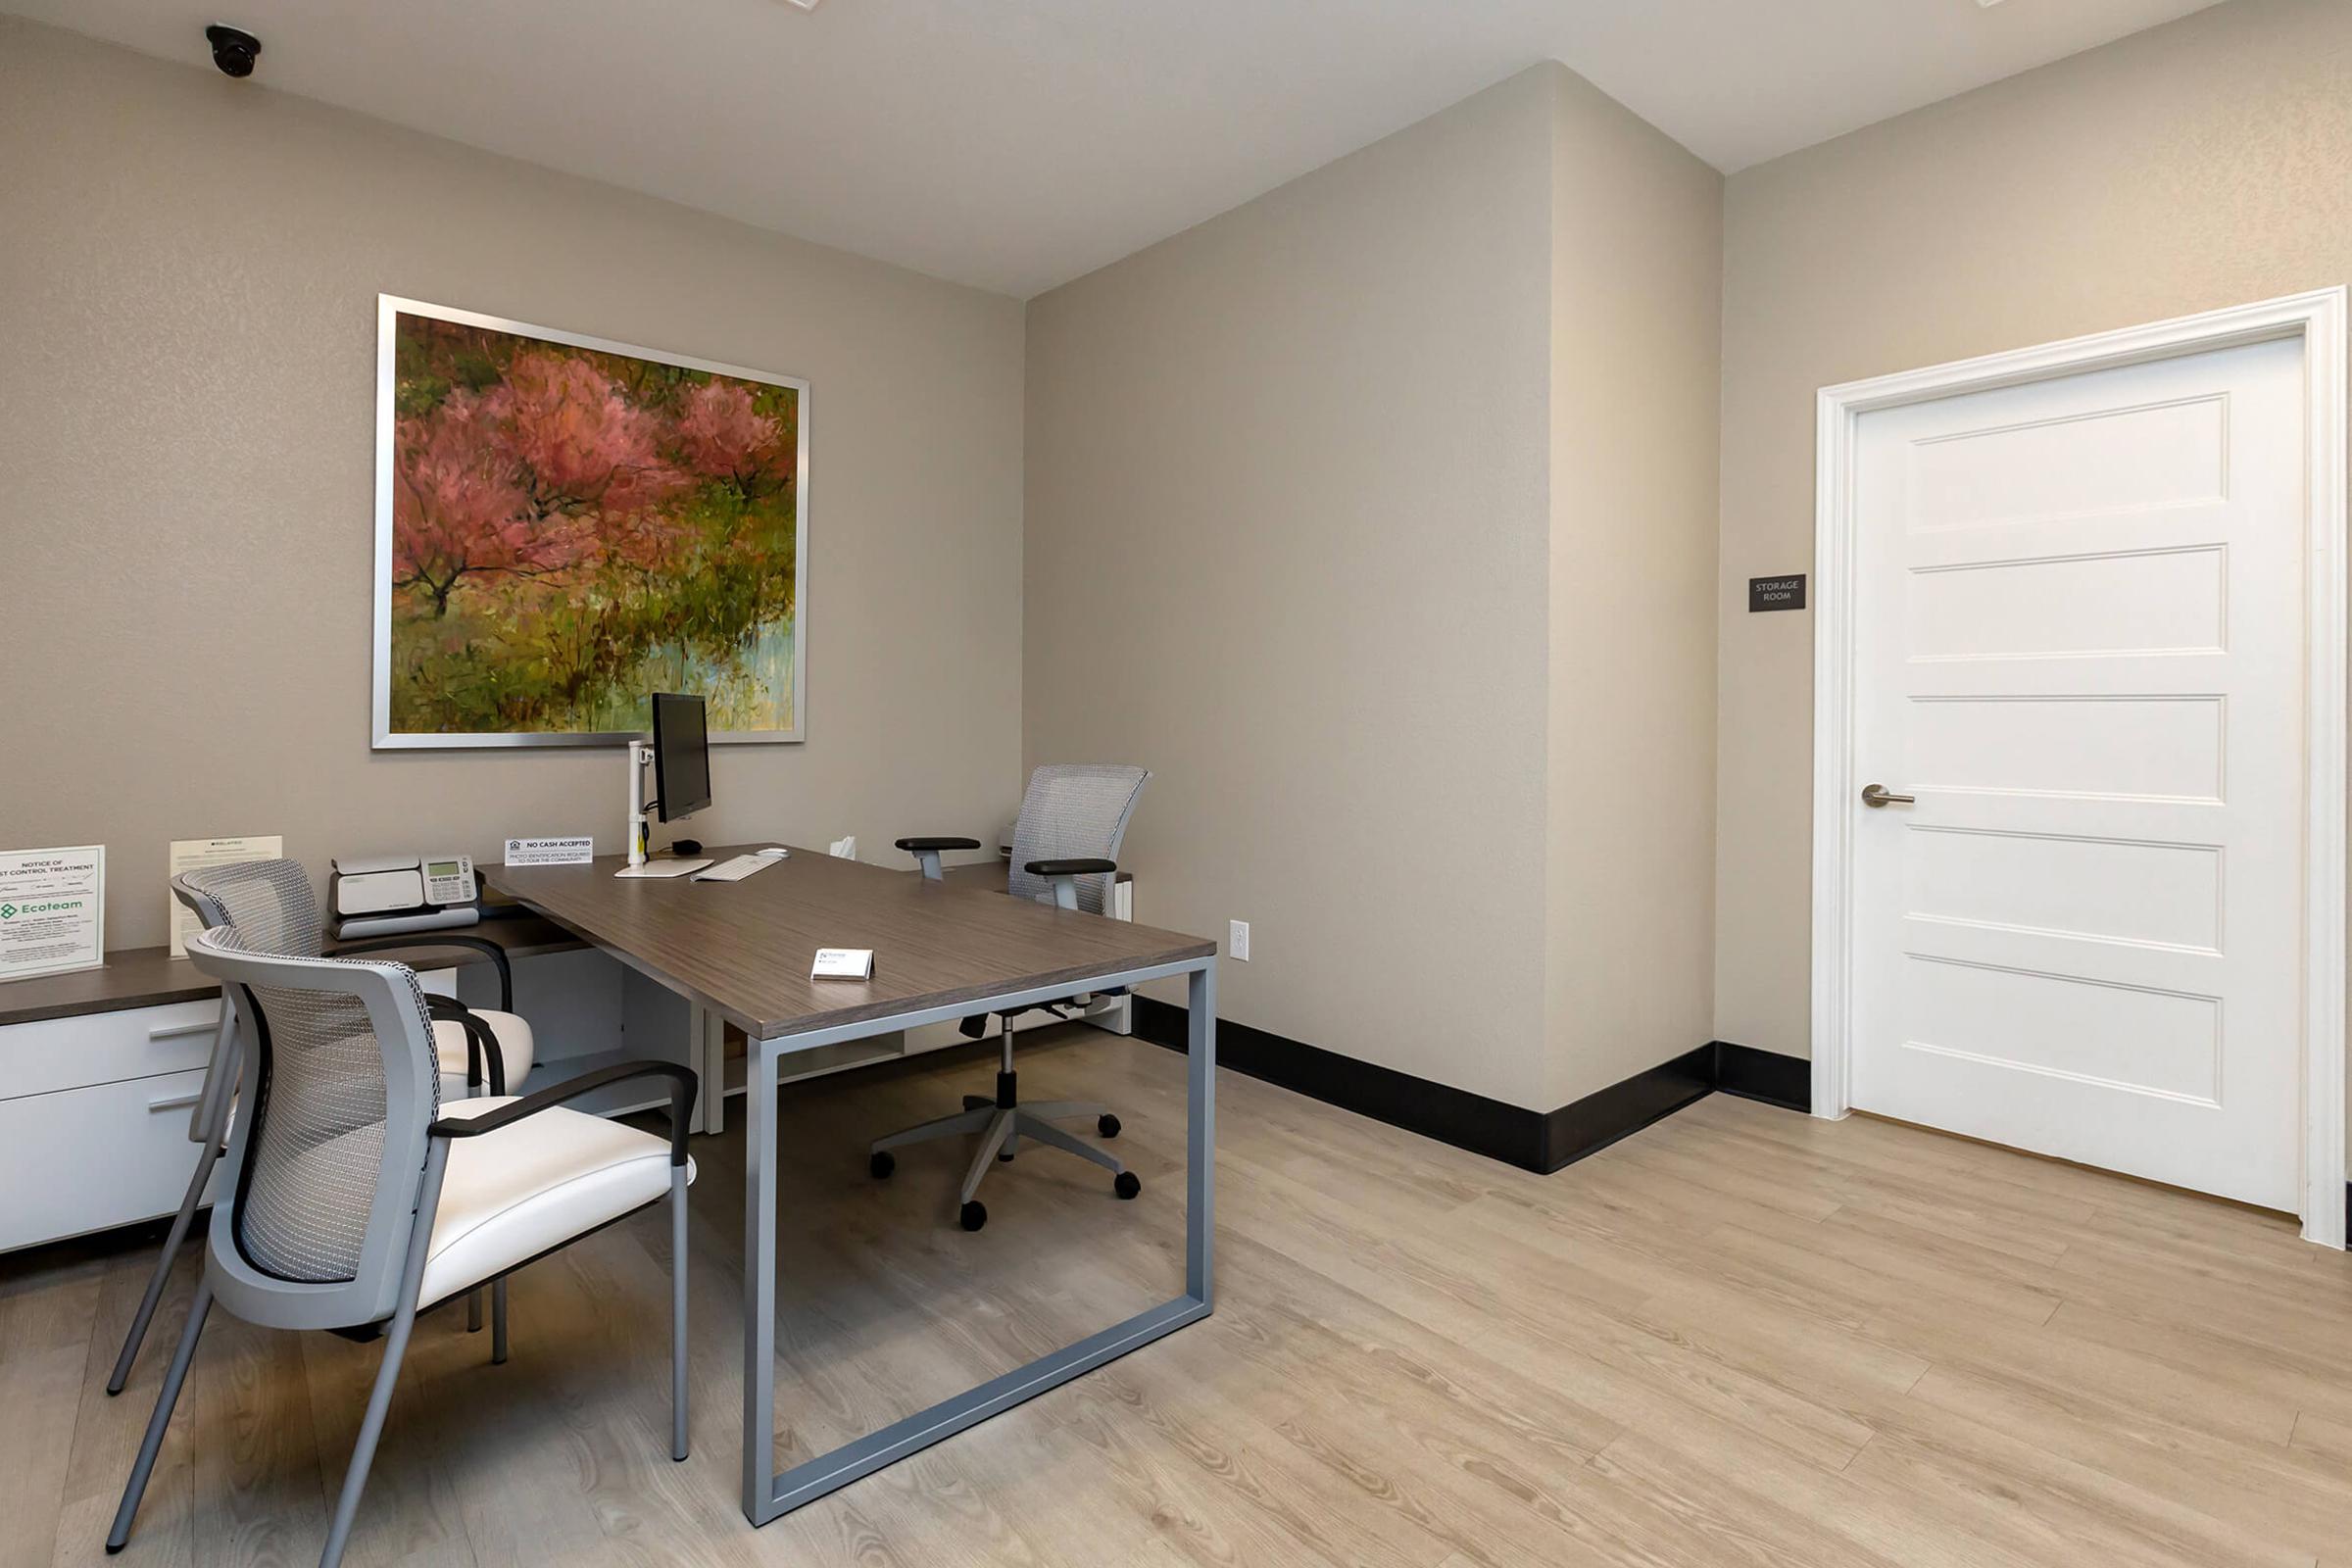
1715,0,2352,1055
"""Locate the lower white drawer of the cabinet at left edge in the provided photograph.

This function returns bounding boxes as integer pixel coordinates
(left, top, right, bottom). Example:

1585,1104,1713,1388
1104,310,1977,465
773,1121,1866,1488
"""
0,1069,205,1253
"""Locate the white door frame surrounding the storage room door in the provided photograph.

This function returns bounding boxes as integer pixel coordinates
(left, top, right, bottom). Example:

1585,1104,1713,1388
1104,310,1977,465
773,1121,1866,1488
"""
1813,287,2347,1249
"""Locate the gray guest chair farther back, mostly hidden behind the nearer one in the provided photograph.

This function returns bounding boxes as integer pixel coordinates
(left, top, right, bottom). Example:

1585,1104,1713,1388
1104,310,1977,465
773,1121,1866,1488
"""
106,860,531,1394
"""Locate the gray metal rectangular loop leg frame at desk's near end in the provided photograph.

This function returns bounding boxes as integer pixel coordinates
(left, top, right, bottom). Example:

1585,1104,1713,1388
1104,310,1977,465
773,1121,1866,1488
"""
743,955,1216,1526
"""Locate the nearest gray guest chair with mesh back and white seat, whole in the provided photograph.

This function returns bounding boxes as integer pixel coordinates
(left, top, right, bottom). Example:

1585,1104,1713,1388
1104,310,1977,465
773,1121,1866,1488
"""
106,926,694,1568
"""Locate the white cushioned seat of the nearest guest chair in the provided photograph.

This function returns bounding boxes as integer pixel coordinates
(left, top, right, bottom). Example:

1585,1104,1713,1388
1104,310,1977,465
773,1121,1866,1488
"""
416,1096,694,1307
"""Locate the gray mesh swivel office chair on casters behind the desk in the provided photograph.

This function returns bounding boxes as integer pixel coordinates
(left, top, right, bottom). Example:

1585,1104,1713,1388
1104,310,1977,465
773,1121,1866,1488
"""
868,764,1151,1230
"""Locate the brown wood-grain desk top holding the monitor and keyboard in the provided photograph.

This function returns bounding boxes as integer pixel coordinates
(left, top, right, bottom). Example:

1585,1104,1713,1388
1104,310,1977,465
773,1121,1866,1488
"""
482,844,1216,1039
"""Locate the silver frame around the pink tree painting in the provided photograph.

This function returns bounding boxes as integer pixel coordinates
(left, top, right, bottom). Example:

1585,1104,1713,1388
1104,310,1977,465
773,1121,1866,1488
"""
369,294,809,753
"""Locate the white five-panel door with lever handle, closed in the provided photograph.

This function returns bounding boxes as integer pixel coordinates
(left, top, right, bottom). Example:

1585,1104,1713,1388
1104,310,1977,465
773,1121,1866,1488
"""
1851,341,2305,1210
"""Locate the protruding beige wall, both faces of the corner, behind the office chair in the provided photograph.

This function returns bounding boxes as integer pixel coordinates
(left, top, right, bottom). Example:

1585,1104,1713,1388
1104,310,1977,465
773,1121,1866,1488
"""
1023,64,1722,1109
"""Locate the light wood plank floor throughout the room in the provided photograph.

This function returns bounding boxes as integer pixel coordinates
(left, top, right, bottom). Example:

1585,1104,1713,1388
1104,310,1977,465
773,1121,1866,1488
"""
0,1032,2352,1568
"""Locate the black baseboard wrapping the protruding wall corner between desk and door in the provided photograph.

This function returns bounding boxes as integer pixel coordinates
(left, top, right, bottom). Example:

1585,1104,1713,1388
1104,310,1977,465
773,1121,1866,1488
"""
1136,997,1813,1173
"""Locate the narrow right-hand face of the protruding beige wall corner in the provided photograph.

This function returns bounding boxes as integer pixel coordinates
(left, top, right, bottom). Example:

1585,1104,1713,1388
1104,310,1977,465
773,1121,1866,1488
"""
1543,66,1724,1104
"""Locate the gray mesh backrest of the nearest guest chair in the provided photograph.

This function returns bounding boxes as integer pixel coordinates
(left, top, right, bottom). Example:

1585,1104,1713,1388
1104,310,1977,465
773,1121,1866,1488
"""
188,926,440,1328
